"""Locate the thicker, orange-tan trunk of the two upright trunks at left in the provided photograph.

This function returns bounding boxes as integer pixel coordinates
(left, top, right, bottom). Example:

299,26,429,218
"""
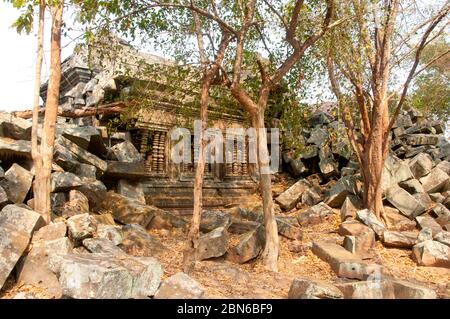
34,1,64,223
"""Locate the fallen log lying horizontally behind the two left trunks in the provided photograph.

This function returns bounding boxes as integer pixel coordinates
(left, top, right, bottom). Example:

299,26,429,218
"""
12,102,131,119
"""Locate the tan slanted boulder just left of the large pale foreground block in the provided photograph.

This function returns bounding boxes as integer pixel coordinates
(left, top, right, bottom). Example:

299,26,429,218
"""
18,236,72,298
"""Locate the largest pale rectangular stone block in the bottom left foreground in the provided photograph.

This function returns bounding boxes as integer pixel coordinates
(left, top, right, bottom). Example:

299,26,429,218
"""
50,254,162,299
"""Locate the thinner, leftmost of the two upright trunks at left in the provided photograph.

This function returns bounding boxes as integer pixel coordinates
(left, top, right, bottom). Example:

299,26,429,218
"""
31,0,49,223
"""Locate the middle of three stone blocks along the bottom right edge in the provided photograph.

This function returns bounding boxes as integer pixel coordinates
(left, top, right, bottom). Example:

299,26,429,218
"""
336,280,395,299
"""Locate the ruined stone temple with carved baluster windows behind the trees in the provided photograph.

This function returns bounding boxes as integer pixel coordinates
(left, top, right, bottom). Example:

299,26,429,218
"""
41,40,256,211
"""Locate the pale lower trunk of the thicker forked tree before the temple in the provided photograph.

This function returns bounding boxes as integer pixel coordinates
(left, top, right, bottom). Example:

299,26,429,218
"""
252,108,279,271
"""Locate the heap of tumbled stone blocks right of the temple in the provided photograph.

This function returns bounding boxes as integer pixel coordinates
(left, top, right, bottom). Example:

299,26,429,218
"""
275,111,450,298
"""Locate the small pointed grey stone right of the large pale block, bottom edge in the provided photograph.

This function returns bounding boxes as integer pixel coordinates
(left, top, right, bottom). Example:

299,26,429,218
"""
155,272,205,299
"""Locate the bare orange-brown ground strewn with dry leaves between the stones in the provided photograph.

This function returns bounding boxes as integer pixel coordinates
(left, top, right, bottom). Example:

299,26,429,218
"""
0,175,450,298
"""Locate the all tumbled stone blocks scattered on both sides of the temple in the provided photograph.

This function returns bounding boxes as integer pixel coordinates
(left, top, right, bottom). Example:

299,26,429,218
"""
0,106,450,299
